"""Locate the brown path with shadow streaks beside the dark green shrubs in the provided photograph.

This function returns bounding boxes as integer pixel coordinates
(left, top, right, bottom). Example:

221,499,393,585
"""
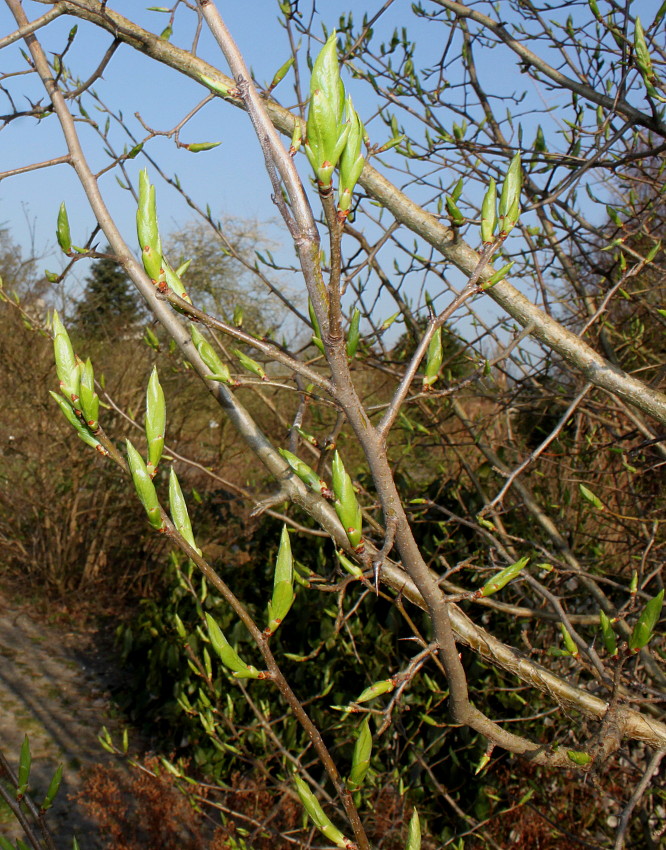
0,594,129,850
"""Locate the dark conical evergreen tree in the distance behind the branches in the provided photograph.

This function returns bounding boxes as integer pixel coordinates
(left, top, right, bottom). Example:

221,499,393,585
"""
74,248,141,337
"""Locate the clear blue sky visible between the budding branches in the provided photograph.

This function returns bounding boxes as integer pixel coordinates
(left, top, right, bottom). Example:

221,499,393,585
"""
0,0,660,332
